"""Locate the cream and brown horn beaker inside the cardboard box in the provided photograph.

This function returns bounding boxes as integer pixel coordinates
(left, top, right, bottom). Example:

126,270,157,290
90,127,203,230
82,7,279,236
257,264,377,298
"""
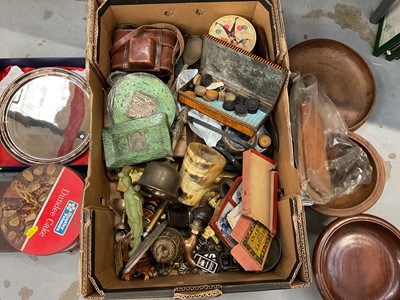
179,143,226,206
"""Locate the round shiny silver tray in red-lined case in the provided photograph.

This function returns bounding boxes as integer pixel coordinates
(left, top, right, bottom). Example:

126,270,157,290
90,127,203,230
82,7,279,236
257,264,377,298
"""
0,68,90,164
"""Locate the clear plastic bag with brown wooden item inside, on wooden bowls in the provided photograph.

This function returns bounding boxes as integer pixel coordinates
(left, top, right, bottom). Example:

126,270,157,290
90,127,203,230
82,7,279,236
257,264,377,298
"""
290,74,372,205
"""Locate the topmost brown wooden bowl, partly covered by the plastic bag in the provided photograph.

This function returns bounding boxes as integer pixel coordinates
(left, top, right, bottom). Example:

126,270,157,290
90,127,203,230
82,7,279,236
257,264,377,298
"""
289,39,376,131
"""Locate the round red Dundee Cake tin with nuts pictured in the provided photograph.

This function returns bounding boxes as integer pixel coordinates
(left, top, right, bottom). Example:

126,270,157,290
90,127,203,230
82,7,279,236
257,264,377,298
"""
0,164,84,255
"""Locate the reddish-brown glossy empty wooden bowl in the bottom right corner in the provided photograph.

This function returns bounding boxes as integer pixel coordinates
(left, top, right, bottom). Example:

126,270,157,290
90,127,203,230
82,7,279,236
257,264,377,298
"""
313,214,400,300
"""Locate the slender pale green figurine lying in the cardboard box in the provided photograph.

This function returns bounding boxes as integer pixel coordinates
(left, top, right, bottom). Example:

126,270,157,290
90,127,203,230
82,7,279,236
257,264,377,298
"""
118,172,143,256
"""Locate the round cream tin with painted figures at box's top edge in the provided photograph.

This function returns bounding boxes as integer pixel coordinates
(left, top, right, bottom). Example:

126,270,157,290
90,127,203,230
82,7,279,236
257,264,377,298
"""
208,15,257,52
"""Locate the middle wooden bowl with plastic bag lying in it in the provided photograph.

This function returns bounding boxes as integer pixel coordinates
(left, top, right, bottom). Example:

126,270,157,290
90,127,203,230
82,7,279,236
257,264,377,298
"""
311,132,386,218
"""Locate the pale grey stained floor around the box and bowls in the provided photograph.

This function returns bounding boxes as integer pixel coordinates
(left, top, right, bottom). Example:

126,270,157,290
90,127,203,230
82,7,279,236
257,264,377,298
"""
0,0,400,300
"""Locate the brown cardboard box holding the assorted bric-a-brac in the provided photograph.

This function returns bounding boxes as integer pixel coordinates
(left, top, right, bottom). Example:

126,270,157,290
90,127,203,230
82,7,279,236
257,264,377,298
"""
80,0,311,299
